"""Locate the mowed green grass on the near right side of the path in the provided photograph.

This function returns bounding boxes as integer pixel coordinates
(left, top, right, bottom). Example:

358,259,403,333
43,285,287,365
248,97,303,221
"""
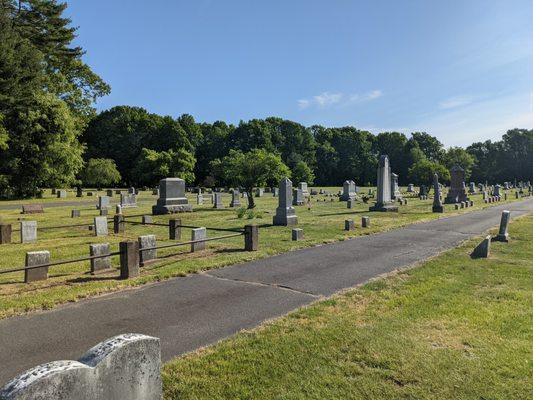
163,216,533,400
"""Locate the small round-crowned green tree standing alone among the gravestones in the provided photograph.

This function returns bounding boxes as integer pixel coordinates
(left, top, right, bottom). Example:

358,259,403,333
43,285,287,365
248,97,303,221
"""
211,149,290,209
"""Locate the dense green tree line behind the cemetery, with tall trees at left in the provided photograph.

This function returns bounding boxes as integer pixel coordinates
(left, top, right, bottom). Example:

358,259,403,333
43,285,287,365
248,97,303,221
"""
0,0,533,198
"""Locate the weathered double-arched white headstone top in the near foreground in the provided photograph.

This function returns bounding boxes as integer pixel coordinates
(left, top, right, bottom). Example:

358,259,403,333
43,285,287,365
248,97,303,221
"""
0,333,162,400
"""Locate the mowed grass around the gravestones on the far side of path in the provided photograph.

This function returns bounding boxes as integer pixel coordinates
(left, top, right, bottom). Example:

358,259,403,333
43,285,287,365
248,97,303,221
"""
0,188,515,318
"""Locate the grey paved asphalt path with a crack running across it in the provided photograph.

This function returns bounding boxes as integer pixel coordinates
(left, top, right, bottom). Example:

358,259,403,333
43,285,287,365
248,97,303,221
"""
0,199,533,383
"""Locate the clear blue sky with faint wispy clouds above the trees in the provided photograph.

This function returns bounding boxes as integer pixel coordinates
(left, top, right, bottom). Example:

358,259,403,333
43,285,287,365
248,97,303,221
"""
67,0,533,146
